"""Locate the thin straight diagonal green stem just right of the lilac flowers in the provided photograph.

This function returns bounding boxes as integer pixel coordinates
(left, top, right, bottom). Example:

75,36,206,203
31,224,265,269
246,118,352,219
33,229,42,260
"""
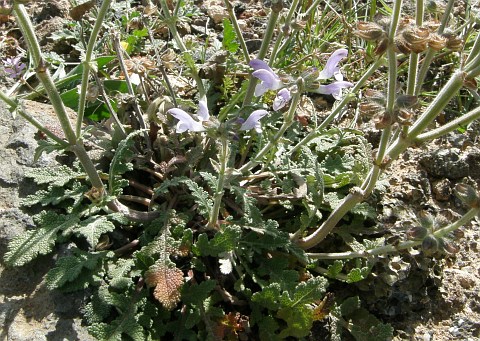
288,57,384,157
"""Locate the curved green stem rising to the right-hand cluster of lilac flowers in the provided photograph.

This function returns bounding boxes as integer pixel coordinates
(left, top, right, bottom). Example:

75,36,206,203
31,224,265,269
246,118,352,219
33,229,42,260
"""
238,78,304,173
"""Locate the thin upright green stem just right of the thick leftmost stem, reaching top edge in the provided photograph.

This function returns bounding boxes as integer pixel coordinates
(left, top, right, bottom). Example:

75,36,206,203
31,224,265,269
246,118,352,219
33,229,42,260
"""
76,0,112,138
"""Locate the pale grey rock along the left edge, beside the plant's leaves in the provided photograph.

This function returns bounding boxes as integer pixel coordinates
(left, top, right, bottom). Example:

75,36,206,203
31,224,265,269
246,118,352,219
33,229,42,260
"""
0,102,93,341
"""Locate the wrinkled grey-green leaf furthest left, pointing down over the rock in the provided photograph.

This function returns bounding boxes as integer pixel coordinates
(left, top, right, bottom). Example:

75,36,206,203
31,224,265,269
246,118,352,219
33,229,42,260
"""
5,211,79,266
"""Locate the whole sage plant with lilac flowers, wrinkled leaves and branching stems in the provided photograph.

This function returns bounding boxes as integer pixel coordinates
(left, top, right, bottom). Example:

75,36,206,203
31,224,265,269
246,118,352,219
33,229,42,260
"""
0,0,480,340
